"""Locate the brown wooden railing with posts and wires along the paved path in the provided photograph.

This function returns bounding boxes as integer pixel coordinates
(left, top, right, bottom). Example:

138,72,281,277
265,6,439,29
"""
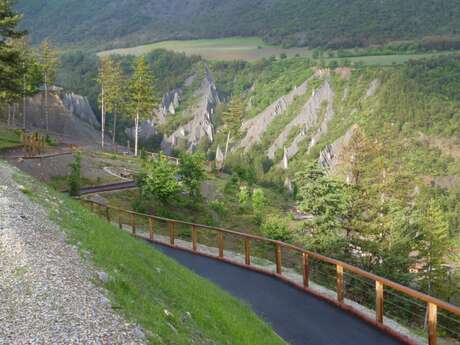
81,199,460,345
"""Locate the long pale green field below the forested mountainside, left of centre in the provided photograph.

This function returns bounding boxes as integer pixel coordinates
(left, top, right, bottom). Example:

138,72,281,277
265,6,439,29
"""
99,37,311,61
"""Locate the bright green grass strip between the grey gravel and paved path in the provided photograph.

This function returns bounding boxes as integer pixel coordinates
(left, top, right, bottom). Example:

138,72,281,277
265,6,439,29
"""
11,163,284,345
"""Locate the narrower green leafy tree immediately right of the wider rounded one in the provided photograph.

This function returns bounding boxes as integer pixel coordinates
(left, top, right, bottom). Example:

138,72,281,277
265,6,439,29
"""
178,152,206,198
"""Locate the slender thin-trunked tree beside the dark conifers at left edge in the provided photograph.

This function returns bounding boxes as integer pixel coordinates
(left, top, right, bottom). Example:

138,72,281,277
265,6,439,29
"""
39,40,58,131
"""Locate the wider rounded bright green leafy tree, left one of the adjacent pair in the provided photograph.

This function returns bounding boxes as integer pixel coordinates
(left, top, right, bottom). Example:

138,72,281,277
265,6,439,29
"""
137,153,181,203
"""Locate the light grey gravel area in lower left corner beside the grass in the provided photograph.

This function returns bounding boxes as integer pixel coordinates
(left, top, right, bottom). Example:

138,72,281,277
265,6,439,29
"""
0,162,146,345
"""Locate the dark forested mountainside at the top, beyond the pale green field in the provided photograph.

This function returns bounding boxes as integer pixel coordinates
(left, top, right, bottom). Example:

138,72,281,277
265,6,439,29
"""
18,0,460,48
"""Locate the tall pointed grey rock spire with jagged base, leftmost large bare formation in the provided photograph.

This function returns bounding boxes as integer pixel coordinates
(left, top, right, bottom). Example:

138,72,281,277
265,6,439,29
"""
161,68,220,154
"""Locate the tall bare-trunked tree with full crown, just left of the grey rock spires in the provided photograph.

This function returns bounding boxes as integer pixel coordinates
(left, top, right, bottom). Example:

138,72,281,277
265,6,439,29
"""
128,57,157,157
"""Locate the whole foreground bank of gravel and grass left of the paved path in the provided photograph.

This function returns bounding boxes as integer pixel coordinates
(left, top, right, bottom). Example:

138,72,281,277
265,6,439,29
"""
0,161,284,345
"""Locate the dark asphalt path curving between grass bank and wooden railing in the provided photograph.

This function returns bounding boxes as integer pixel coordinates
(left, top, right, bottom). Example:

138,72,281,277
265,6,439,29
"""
155,245,401,345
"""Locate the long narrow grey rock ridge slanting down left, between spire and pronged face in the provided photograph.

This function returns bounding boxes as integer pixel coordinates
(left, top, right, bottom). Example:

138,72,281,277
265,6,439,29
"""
238,81,308,152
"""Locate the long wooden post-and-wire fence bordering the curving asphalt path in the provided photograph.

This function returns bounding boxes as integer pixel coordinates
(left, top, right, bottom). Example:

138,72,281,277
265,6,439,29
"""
81,199,460,345
